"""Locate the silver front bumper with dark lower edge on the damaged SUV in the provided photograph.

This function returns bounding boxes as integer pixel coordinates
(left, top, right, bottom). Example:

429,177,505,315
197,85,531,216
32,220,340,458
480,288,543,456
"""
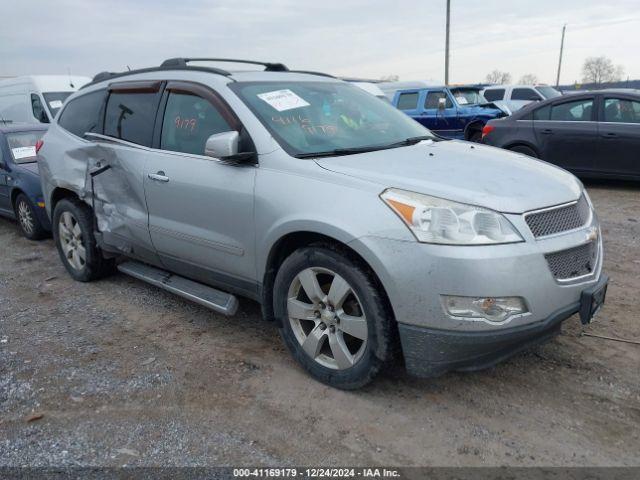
352,208,607,376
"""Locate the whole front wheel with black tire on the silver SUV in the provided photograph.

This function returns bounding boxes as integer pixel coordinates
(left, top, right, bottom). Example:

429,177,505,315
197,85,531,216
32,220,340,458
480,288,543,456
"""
273,246,394,390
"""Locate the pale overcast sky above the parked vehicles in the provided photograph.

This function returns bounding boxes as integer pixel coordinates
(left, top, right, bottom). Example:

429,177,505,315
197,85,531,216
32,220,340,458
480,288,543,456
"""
0,0,640,84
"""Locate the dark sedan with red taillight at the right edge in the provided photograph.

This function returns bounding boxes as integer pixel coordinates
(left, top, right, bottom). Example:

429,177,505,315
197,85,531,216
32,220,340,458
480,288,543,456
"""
483,90,640,179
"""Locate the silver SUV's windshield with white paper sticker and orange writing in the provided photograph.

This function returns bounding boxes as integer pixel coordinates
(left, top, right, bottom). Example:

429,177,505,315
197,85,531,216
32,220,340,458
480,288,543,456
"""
229,82,435,158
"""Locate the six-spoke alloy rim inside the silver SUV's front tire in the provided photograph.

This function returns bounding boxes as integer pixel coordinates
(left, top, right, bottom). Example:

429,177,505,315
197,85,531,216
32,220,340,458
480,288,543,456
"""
287,267,368,370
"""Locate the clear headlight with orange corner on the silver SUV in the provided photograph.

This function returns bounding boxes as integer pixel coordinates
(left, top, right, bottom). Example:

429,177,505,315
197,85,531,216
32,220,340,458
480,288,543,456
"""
380,188,523,245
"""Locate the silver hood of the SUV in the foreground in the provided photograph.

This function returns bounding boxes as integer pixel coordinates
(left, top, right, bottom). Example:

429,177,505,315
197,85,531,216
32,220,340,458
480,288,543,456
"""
316,141,582,213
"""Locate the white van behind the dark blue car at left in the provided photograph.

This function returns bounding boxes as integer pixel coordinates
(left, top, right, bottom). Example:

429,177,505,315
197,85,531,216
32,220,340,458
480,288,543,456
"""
0,75,91,123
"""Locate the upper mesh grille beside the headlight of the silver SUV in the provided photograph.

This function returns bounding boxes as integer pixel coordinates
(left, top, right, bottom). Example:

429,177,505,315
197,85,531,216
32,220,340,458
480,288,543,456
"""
525,195,589,238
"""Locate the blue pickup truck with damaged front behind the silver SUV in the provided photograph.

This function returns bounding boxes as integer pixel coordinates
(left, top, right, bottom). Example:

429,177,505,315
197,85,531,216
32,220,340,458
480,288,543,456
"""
392,86,507,142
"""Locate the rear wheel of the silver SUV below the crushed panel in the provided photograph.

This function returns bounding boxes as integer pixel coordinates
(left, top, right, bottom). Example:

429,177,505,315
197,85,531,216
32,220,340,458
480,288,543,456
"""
53,198,115,282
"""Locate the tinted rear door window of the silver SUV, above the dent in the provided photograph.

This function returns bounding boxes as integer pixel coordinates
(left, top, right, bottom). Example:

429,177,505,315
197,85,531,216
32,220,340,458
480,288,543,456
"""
104,91,159,147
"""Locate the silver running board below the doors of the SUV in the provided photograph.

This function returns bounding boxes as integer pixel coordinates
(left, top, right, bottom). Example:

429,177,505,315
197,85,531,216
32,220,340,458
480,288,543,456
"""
118,261,238,316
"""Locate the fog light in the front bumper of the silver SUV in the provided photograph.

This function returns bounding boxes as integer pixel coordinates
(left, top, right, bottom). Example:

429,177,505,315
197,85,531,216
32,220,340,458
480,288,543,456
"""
442,295,529,323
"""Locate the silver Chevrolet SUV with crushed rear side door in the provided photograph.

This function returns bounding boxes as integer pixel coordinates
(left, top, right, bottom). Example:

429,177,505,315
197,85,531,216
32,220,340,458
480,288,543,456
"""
39,58,607,389
